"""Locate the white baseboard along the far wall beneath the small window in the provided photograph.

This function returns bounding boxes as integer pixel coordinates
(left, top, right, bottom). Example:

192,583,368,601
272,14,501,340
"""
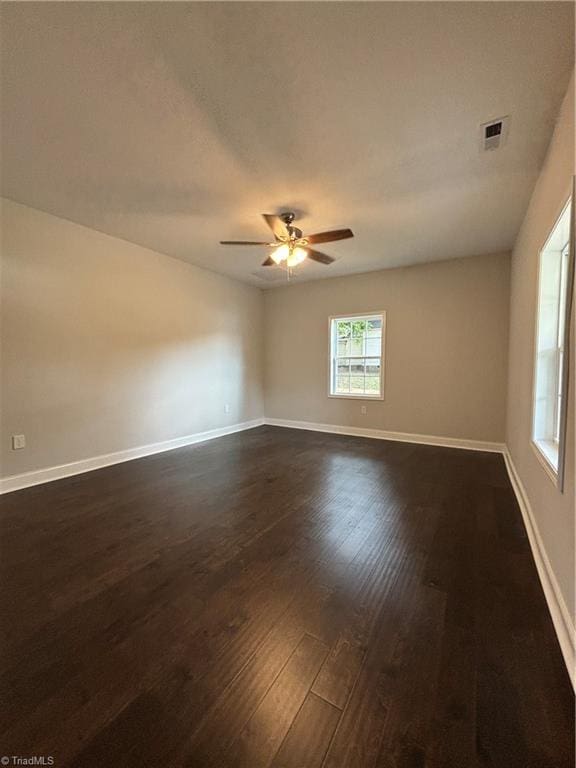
265,418,506,453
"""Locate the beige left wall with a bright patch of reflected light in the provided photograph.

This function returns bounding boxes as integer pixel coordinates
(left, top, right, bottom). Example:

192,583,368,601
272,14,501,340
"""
1,201,263,476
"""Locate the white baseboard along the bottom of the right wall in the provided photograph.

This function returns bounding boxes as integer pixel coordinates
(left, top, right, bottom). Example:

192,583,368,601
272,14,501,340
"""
504,449,576,690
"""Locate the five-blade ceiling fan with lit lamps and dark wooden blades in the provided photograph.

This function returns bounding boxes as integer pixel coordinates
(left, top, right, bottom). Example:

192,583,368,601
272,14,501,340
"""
220,211,354,269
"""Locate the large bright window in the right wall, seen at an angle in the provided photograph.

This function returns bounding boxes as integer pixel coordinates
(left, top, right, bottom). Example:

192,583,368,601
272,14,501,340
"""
532,200,572,485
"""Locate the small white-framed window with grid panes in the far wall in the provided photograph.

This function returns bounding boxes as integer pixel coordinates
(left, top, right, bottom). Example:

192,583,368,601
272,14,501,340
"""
329,312,385,400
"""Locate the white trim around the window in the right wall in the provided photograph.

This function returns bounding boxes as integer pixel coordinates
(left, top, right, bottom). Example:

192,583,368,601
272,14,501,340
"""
530,184,576,493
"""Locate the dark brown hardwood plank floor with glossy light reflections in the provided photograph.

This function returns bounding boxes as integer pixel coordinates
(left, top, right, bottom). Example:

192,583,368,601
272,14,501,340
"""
0,427,574,768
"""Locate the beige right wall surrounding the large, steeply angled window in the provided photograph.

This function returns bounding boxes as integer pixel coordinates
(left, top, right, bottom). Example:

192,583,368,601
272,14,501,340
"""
506,77,576,615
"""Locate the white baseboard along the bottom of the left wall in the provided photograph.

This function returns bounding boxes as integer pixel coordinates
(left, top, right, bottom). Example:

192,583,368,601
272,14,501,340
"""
0,419,264,494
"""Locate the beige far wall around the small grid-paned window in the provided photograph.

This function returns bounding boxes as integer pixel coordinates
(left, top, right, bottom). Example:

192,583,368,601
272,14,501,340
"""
265,254,509,441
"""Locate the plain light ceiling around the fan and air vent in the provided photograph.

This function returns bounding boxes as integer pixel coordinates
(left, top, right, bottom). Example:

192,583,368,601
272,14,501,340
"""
2,2,574,287
